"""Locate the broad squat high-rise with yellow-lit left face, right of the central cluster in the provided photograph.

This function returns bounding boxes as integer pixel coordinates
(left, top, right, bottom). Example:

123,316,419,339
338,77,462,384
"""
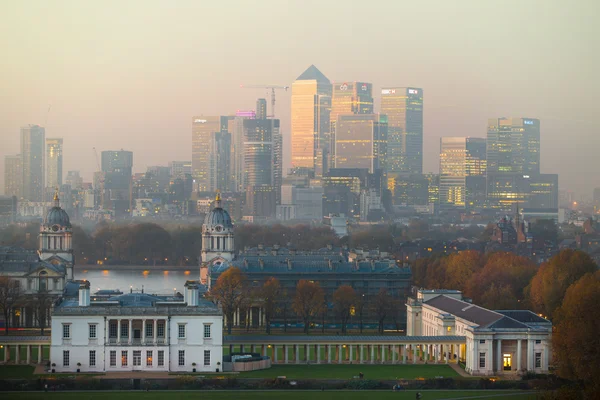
440,137,486,209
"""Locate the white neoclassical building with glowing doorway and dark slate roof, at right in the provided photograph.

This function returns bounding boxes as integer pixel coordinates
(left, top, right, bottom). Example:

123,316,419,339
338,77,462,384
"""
406,290,552,376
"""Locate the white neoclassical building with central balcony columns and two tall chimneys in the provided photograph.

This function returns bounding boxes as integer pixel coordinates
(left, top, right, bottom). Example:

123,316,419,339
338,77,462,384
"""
50,281,223,372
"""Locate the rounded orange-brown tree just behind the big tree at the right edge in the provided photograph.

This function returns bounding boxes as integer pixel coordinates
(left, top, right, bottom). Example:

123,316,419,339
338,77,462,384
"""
529,249,598,319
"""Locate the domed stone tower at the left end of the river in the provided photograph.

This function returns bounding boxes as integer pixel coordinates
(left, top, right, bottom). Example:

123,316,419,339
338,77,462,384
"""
38,190,74,280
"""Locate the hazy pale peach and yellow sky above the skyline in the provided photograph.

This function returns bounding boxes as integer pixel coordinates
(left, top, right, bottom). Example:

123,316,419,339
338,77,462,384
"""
0,0,600,198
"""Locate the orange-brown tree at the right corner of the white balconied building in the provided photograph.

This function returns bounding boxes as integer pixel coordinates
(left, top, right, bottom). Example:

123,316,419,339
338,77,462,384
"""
210,267,247,334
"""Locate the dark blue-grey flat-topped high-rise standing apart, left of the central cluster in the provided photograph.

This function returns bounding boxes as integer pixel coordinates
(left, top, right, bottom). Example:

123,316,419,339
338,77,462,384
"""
102,150,133,218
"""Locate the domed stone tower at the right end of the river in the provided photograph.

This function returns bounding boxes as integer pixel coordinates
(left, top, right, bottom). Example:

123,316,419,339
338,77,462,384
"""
200,193,235,285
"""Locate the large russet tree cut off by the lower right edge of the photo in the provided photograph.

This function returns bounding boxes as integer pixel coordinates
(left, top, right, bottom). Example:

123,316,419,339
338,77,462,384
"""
552,271,600,398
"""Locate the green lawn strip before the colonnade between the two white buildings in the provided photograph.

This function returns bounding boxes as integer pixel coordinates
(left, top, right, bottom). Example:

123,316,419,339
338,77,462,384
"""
240,364,460,380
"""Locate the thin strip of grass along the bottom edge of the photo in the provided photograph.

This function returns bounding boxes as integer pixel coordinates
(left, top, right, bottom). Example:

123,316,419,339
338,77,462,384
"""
0,390,536,400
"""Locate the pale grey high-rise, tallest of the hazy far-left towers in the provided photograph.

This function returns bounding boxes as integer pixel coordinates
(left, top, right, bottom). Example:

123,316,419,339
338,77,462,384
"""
21,125,46,201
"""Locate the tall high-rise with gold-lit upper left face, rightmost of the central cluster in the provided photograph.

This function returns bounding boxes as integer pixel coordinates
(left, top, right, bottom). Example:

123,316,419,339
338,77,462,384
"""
381,87,423,174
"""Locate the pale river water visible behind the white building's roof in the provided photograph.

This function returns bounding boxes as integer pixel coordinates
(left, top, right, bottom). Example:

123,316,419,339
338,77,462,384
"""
74,265,200,294
